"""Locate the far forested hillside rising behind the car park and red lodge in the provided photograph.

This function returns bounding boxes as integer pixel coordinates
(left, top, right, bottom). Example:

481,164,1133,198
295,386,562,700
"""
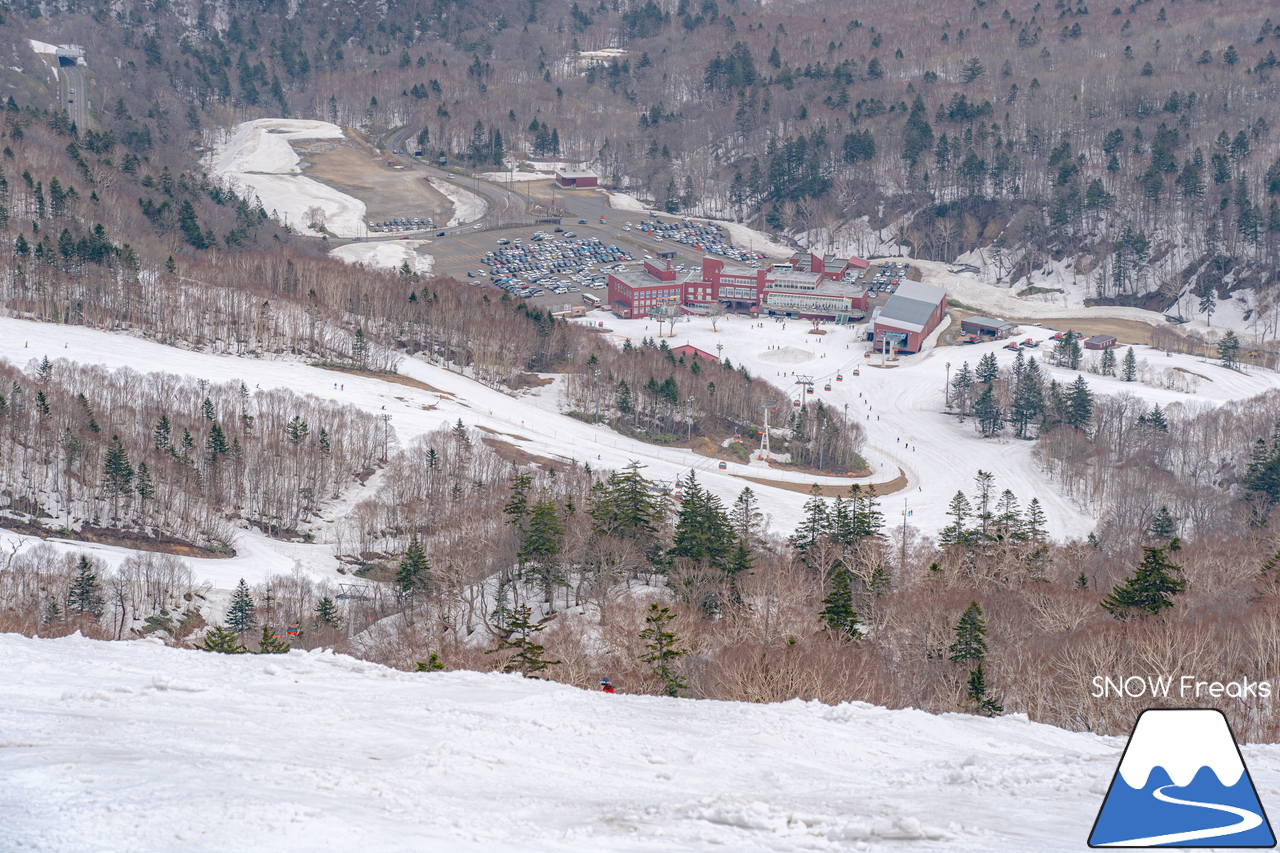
5,0,1280,317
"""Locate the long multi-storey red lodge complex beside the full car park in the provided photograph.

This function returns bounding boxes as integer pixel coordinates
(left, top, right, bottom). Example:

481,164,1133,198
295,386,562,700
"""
608,250,870,323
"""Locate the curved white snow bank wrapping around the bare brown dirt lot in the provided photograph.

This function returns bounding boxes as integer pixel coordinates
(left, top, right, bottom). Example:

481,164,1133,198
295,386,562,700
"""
207,119,366,237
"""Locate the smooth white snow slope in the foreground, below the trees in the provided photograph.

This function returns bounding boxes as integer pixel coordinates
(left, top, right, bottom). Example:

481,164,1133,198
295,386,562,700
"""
0,634,1162,853
